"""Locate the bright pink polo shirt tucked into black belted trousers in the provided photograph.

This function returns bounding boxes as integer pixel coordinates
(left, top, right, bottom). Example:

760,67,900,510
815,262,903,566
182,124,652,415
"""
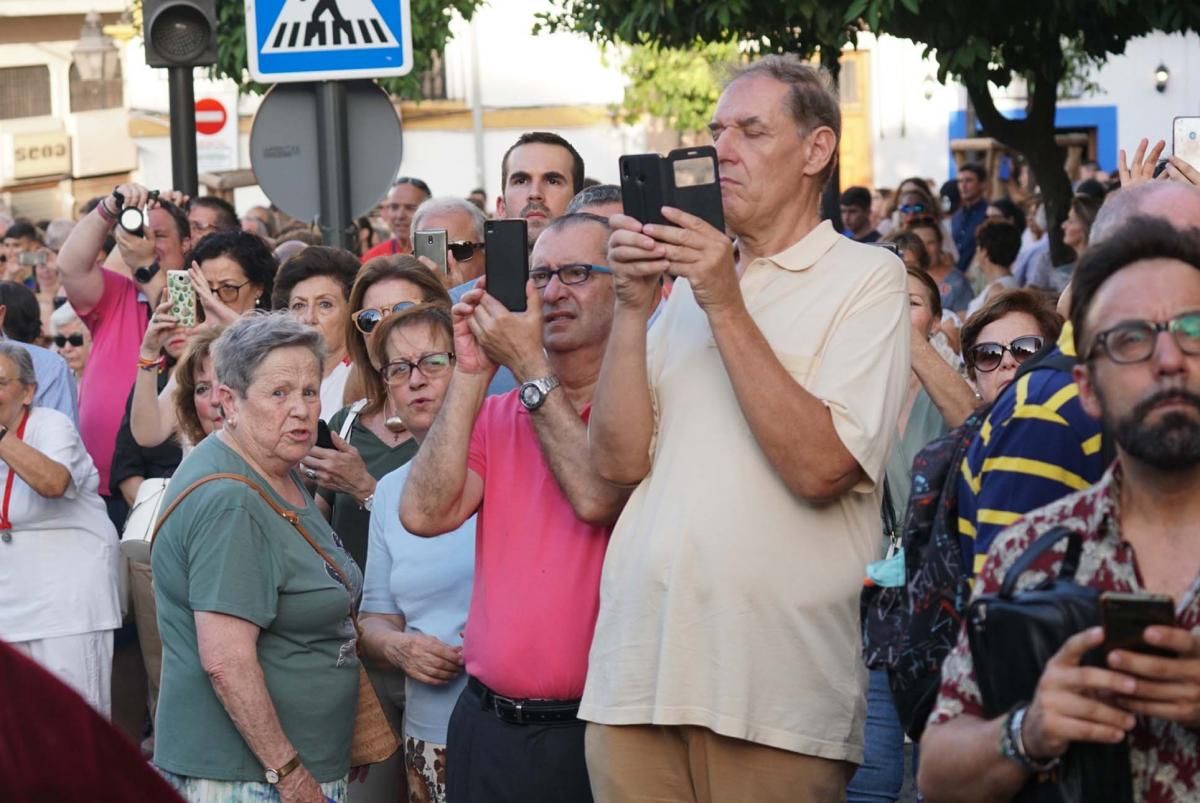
463,390,612,700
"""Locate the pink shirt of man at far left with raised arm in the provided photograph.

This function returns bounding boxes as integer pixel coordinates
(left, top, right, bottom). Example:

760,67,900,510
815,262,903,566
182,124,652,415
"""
79,268,150,496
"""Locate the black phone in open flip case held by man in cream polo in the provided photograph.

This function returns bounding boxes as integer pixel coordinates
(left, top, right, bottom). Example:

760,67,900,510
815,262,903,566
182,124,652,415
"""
618,145,725,232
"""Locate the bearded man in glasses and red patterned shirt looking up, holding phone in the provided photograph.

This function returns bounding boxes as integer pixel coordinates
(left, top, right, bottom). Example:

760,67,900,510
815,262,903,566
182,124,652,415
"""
919,217,1200,803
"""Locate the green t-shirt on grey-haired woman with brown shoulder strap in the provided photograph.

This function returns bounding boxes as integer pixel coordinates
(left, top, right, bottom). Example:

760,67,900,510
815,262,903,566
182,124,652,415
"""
151,436,362,783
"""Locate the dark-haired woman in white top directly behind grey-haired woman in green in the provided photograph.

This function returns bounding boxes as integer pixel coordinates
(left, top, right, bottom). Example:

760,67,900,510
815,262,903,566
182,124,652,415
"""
271,245,359,421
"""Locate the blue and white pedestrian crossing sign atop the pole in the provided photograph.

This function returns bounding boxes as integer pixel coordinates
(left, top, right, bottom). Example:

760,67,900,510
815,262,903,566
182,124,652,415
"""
246,0,413,84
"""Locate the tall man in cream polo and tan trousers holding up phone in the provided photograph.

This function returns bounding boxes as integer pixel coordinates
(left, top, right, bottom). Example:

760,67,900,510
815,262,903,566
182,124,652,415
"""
580,56,911,803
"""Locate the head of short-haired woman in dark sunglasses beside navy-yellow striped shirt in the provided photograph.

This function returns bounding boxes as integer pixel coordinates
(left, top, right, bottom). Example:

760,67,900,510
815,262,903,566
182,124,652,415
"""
962,289,1062,405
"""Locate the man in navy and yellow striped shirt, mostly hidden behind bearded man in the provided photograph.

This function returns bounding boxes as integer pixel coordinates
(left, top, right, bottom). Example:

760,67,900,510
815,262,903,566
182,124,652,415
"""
958,181,1200,574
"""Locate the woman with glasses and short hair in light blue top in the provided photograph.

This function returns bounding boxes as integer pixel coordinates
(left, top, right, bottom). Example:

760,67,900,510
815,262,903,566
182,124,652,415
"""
362,305,475,803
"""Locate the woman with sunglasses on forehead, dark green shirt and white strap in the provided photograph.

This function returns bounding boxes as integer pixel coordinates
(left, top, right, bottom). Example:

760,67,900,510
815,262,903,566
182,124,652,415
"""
301,254,450,567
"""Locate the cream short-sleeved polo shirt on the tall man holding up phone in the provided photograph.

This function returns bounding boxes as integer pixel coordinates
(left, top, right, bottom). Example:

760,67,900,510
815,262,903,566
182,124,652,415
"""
580,222,912,762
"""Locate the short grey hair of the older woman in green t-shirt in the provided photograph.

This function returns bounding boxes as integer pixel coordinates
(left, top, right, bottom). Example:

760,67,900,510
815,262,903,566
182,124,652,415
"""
211,311,325,398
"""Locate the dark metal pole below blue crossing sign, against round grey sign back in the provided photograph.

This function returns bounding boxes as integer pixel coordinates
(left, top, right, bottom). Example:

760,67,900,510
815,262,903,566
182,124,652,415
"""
316,80,354,248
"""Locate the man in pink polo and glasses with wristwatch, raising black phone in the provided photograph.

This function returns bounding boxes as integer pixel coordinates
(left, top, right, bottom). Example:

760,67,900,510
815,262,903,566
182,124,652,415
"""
400,214,626,803
